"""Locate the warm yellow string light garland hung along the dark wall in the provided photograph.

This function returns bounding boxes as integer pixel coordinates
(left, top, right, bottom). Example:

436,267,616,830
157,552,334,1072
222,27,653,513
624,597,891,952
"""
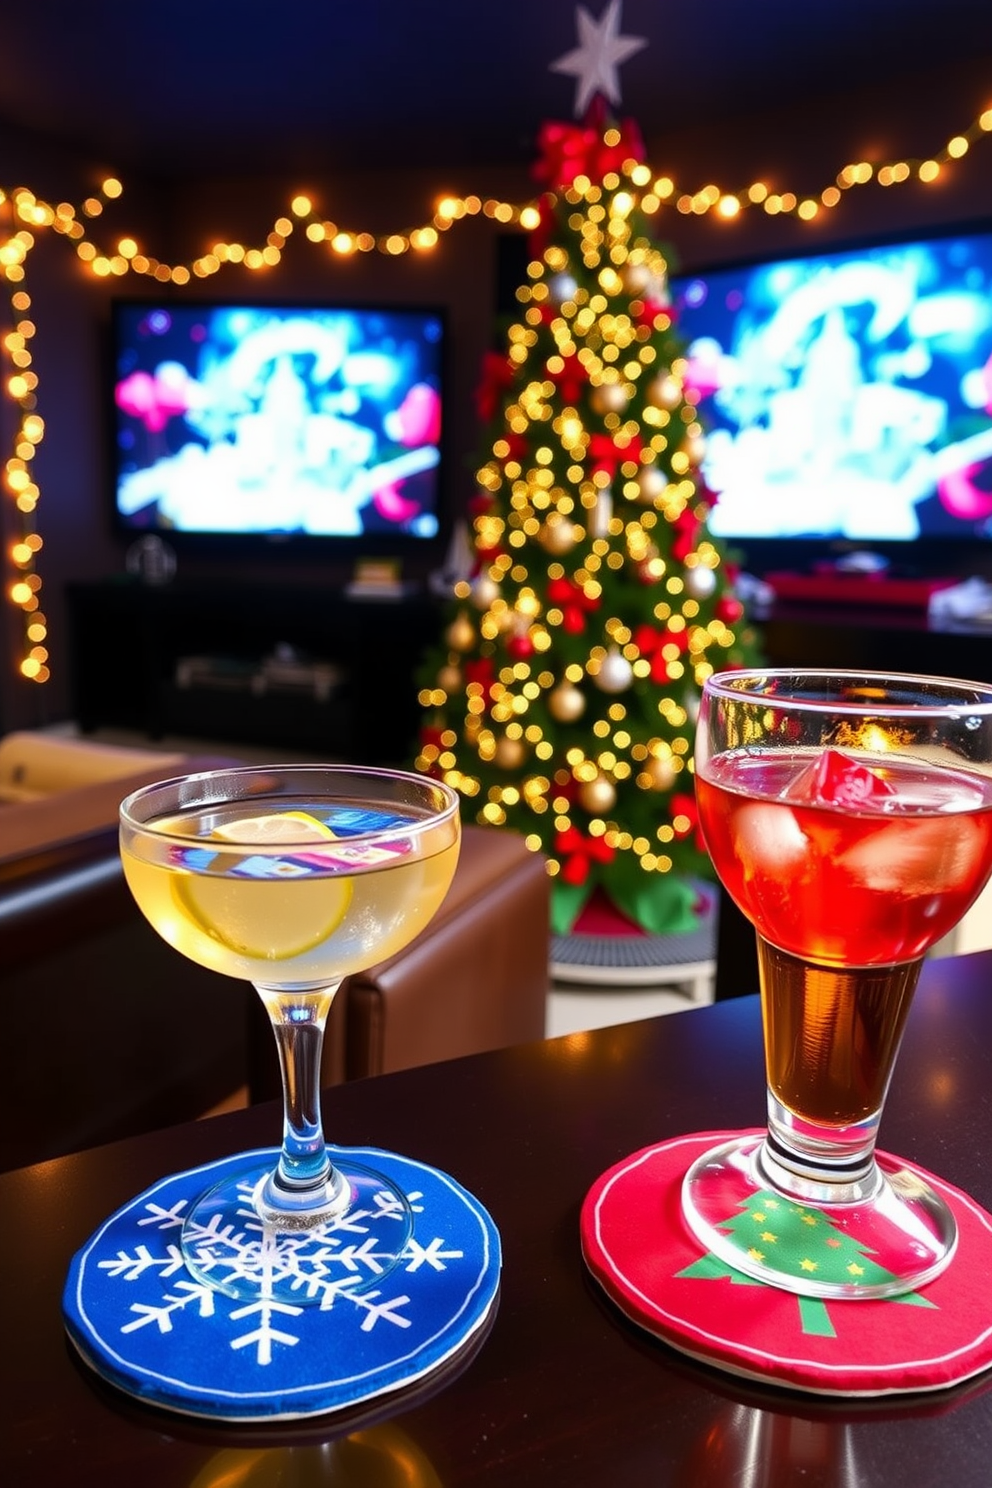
0,98,992,683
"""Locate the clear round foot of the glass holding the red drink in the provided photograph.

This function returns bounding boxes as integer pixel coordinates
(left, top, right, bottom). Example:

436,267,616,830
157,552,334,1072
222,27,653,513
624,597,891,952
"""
683,1134,958,1299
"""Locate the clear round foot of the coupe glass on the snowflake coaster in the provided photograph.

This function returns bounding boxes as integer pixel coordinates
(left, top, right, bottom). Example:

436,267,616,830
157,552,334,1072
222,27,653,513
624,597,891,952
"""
181,1153,413,1308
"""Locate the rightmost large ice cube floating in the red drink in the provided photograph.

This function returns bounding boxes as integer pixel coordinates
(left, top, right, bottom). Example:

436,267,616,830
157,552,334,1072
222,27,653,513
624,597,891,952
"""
839,815,985,896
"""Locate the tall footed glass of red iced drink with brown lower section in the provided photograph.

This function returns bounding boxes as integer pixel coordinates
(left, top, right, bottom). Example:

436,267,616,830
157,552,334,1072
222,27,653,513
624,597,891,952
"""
683,670,992,1298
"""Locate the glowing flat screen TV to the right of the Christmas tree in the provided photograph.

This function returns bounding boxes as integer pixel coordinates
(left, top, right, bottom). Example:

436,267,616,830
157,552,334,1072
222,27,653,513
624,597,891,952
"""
672,225,992,574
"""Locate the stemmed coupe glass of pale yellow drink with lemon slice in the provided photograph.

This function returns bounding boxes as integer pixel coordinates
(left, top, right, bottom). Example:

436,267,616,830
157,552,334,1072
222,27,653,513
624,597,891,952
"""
120,765,461,1305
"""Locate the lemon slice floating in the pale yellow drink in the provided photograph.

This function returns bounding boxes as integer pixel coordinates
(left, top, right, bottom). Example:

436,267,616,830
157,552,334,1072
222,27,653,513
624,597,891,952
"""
174,811,354,975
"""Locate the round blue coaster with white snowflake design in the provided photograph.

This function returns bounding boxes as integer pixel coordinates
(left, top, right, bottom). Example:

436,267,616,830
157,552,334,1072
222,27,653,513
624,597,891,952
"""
62,1147,500,1421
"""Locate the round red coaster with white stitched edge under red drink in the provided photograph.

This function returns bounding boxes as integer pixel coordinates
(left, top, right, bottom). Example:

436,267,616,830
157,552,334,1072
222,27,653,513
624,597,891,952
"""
580,1131,992,1396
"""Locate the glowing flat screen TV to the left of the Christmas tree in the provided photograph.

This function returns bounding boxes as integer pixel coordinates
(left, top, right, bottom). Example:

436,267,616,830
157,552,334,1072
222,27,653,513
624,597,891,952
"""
112,298,446,557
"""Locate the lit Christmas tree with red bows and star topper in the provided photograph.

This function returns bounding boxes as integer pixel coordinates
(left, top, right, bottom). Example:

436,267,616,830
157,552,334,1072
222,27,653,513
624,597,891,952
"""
416,3,754,934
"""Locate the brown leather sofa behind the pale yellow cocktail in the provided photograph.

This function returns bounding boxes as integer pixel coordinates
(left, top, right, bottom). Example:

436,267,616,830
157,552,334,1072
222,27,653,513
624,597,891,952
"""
0,732,549,1171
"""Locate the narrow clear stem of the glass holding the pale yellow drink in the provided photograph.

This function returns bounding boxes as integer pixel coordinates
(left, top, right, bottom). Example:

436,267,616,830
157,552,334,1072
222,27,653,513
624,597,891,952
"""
256,982,341,1204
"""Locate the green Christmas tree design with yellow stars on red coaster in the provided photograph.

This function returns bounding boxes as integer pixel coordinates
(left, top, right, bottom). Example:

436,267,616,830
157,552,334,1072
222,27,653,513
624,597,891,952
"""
677,1189,935,1338
